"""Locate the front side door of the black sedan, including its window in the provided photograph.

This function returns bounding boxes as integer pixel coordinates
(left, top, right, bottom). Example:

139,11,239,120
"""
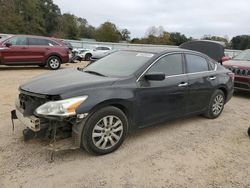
136,53,188,127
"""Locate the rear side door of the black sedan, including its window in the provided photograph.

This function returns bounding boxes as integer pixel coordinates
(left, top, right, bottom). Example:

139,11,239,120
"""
185,53,217,113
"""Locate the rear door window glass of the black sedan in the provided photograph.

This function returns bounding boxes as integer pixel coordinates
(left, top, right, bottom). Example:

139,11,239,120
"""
186,54,209,73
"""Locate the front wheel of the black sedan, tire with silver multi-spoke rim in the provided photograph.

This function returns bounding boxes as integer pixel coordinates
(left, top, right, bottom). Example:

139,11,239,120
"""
81,106,128,155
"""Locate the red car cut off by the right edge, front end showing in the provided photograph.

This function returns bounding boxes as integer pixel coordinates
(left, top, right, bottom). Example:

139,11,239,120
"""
223,49,250,91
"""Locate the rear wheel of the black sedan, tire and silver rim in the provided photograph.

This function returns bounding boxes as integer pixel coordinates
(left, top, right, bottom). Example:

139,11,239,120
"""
204,89,225,119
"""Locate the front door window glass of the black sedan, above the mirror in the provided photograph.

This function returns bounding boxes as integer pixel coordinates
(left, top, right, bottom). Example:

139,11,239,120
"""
149,54,183,76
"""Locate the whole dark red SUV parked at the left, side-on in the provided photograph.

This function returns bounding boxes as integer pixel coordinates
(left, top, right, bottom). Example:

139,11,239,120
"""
0,35,69,70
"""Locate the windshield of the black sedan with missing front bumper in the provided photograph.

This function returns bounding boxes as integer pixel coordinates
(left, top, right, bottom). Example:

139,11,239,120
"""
84,51,154,77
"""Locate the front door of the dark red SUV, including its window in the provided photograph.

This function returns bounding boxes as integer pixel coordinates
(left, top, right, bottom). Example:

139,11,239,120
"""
1,36,29,65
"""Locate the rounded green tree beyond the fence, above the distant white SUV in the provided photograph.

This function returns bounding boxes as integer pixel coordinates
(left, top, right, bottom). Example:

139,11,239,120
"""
95,22,121,42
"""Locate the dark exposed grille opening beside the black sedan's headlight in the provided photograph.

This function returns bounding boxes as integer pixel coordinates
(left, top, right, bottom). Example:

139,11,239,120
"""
19,93,47,116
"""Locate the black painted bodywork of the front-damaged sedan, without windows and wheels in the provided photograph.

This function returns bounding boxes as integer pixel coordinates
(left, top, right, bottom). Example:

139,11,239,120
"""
20,50,233,133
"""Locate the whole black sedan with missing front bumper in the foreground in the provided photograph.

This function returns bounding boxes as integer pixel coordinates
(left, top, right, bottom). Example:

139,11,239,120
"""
12,49,233,155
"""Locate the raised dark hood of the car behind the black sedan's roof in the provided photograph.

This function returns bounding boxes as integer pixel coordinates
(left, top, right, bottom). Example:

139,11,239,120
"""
179,40,231,63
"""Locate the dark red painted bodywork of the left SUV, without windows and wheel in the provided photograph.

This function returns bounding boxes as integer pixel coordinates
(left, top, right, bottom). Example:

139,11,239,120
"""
0,35,69,65
